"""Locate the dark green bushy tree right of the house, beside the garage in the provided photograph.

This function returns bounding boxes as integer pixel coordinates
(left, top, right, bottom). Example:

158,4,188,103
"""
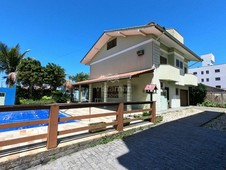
189,83,207,105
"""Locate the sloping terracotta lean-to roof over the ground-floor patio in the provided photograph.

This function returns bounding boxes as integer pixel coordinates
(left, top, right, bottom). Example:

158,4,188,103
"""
73,68,154,86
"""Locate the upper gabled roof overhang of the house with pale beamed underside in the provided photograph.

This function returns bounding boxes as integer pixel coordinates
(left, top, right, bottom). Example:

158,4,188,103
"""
81,23,201,64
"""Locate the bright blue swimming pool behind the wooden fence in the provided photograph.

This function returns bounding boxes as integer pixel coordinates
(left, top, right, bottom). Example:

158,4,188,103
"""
0,109,77,132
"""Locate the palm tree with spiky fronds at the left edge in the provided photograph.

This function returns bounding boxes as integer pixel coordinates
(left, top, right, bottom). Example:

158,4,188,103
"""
0,42,30,87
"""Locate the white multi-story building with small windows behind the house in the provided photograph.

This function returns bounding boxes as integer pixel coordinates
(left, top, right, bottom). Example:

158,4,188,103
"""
189,53,226,89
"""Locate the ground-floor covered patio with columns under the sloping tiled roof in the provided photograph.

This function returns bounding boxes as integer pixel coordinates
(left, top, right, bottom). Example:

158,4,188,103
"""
73,68,154,107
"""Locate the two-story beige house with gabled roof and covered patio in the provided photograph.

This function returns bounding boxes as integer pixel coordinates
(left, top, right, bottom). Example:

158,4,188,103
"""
74,22,201,111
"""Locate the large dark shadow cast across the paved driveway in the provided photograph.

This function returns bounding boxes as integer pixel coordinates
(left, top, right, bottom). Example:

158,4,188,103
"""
118,111,226,169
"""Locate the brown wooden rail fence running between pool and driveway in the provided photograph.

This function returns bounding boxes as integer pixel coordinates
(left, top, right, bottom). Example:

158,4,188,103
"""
0,101,156,149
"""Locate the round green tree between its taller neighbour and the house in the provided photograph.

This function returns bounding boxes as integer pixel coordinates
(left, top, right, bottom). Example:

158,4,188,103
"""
44,63,66,90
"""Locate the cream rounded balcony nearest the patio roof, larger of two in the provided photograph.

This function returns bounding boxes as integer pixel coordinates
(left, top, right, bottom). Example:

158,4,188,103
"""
157,64,180,82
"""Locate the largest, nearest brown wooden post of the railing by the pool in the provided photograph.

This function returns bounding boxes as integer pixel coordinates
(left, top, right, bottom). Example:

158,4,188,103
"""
47,104,59,149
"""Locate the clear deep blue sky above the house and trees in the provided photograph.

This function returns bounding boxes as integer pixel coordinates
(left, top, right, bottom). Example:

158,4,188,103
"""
0,0,226,78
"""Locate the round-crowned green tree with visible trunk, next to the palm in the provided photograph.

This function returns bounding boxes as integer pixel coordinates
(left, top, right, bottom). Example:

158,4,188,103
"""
17,58,44,98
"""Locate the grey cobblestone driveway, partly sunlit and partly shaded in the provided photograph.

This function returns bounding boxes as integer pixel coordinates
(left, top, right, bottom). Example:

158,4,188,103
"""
31,111,226,170
